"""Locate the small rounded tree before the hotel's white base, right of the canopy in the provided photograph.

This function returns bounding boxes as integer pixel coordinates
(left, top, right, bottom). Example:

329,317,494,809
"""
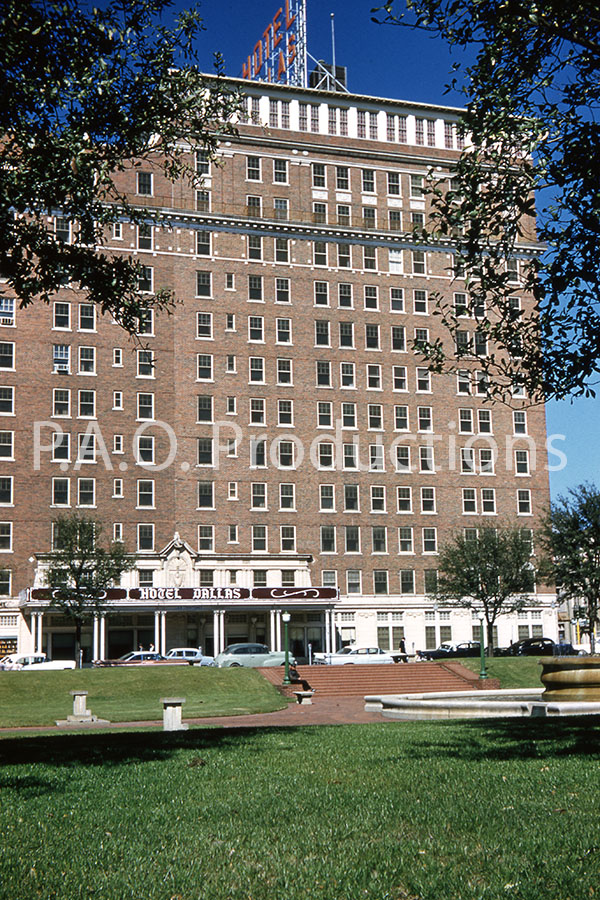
432,526,536,655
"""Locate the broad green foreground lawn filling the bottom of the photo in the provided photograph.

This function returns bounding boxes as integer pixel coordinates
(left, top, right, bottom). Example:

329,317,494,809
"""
0,716,600,900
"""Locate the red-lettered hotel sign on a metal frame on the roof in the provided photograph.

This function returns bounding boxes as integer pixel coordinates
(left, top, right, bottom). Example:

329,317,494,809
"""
242,0,306,87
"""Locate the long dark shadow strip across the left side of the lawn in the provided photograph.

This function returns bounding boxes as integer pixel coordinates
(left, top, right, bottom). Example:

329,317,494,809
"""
0,727,298,768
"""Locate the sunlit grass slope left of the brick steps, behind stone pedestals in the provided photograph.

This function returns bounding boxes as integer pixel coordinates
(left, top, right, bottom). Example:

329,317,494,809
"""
0,666,286,727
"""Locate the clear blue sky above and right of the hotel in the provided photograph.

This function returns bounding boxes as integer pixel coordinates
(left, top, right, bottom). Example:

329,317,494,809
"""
176,0,600,497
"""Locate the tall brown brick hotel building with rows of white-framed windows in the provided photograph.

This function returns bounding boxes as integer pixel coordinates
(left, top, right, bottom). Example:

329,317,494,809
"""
0,79,557,658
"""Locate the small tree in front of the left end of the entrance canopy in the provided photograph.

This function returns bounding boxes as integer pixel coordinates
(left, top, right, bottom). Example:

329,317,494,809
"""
46,514,134,664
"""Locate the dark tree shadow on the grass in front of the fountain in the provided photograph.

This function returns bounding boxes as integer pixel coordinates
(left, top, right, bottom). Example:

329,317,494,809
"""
404,716,600,761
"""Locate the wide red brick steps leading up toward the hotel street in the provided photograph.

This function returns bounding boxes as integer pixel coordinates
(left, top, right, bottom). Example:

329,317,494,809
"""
259,662,488,699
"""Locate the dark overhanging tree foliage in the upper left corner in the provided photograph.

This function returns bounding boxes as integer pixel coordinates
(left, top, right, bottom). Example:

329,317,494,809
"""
0,0,237,332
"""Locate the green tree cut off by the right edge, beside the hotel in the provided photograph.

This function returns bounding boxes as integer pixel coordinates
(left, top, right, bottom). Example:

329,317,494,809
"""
542,484,600,652
